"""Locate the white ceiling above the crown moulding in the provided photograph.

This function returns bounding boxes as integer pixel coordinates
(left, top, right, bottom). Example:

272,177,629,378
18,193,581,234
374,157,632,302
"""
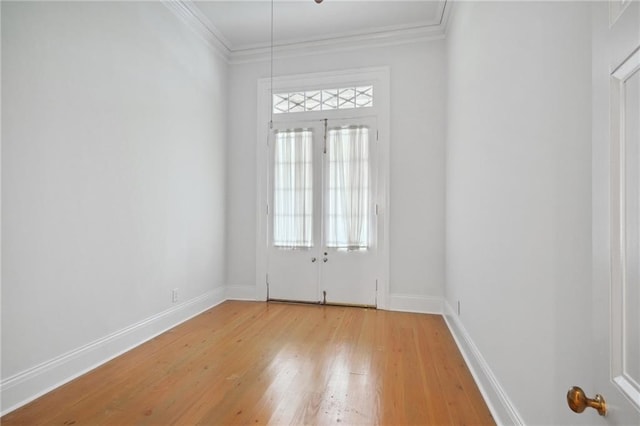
190,0,446,52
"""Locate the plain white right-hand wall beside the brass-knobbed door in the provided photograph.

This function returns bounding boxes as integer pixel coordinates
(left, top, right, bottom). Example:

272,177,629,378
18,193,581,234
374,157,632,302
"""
446,2,597,424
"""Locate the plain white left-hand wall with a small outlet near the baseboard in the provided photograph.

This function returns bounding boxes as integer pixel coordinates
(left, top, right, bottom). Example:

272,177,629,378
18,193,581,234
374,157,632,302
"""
2,1,227,410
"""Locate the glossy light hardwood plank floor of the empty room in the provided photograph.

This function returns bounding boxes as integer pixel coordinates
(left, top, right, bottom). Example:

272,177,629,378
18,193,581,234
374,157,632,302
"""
0,301,495,426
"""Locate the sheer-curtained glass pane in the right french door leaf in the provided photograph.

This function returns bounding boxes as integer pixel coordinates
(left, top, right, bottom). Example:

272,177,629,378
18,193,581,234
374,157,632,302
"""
325,126,371,250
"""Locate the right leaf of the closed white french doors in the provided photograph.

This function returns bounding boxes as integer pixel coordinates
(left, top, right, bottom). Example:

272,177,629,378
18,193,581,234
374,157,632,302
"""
320,118,379,306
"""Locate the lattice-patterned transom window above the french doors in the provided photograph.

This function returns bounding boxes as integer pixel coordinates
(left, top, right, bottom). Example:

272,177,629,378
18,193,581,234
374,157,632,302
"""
273,86,373,114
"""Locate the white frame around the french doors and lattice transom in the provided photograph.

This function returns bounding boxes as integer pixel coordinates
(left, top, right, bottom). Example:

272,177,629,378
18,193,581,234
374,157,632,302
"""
255,67,390,309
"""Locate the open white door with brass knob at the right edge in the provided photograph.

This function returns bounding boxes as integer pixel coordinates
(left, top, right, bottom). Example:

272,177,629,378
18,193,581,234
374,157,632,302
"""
588,0,640,425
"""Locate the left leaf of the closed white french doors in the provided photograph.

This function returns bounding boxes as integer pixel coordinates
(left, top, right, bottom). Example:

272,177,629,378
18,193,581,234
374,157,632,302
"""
267,122,322,302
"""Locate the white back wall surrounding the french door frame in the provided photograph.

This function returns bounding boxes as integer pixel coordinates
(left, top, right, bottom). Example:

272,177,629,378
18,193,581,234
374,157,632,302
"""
227,40,445,298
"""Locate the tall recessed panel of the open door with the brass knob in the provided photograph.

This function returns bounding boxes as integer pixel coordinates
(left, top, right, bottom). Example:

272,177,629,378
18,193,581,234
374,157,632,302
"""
623,71,640,387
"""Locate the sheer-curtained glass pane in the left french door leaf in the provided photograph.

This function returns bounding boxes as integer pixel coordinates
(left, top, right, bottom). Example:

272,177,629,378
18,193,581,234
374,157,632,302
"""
273,129,313,248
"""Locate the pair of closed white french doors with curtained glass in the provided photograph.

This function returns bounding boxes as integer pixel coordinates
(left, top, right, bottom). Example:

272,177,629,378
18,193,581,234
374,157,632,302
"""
267,117,378,306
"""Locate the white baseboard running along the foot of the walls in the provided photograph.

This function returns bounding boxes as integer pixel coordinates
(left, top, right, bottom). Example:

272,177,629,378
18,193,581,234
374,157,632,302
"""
0,285,512,418
